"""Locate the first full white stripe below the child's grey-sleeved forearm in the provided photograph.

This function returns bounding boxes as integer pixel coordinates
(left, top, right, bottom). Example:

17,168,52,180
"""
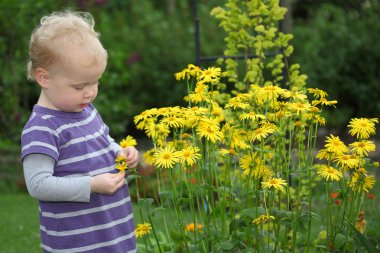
40,196,131,219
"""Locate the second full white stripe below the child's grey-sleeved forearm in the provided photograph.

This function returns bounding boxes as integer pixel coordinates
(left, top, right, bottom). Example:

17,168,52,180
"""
40,213,133,237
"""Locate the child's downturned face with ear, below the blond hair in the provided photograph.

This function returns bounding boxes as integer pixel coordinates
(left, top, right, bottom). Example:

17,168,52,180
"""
43,46,105,112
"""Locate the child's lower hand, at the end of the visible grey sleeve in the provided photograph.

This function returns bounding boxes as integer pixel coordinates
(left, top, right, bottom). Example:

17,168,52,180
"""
91,173,125,195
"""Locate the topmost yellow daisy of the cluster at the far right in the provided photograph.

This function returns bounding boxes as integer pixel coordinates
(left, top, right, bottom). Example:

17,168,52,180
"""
348,118,379,139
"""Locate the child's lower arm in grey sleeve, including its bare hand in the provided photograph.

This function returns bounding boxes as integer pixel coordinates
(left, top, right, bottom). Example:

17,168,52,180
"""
23,154,124,202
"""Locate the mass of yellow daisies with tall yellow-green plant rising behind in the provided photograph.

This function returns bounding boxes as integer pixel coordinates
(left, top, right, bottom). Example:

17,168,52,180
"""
131,0,378,252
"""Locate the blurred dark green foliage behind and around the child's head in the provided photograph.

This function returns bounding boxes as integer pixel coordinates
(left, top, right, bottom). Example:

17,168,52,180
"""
0,0,221,143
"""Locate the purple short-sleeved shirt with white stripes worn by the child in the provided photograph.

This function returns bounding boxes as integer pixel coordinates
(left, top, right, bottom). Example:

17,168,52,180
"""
21,105,136,253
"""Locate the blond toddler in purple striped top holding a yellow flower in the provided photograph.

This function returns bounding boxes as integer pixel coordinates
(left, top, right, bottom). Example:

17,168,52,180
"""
21,11,138,253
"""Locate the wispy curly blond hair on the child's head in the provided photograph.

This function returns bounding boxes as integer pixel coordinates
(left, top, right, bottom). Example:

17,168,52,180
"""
27,11,107,80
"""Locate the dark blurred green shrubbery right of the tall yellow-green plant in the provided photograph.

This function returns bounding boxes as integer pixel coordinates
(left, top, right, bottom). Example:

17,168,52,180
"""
293,0,380,127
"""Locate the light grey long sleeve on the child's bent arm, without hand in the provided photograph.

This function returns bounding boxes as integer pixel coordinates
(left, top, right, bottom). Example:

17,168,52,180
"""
23,154,91,202
